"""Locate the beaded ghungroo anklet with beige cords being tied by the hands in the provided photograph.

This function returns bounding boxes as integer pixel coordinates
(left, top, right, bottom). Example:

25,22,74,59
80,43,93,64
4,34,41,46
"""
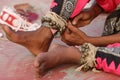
41,12,67,34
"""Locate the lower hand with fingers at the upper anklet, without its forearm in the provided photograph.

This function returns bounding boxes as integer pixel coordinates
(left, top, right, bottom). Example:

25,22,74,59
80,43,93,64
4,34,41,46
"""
62,22,88,45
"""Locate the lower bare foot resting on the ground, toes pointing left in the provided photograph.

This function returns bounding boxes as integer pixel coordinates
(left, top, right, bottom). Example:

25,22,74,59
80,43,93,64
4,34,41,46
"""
34,45,81,77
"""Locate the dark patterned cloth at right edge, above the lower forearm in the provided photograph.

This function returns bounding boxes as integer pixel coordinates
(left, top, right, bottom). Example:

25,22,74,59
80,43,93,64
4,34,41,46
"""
103,5,120,36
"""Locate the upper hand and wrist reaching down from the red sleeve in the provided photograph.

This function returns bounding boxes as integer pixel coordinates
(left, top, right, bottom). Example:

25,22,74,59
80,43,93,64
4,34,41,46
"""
72,4,103,27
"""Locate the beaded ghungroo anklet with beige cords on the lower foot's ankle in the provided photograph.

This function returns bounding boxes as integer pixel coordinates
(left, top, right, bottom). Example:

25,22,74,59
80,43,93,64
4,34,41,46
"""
76,43,98,71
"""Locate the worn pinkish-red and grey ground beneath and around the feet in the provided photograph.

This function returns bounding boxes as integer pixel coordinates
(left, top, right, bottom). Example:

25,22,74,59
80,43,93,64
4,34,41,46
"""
0,0,120,80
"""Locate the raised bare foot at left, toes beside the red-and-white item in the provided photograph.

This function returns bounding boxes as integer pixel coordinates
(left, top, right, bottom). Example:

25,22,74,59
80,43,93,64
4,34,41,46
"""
2,25,53,55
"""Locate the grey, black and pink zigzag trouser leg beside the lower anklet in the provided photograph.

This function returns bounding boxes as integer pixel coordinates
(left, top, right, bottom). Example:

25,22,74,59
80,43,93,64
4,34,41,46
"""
95,46,120,76
